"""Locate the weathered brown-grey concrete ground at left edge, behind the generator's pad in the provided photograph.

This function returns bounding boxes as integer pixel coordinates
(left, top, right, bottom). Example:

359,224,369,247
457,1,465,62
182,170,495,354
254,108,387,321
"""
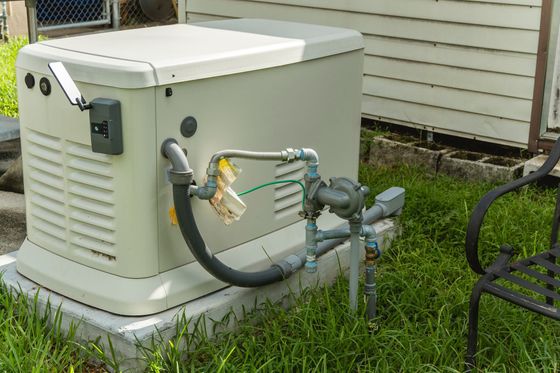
0,191,25,255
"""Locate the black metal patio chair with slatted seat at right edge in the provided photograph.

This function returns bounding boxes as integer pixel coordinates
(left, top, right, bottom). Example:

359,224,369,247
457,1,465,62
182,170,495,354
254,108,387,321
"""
465,140,560,372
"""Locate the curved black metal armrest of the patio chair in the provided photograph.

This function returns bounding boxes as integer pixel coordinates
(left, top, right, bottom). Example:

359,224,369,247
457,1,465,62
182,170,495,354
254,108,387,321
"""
465,138,560,275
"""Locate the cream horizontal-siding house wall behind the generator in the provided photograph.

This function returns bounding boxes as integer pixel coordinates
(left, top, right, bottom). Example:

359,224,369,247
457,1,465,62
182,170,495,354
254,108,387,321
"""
187,0,542,147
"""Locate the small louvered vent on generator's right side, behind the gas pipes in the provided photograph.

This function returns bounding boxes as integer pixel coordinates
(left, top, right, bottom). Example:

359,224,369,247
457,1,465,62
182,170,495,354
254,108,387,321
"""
274,161,306,219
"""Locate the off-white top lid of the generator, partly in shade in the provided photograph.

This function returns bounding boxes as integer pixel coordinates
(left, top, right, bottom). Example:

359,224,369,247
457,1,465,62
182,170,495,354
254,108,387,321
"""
16,19,363,88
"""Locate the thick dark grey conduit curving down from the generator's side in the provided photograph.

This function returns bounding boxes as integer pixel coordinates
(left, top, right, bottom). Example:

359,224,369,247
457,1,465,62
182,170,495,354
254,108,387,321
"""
162,139,402,287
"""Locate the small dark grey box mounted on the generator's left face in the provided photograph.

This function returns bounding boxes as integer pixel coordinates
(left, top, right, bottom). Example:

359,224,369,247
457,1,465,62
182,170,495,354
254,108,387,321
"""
89,98,123,155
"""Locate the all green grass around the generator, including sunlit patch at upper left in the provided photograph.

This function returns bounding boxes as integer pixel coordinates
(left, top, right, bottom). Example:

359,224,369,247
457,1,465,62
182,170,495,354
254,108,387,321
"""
0,39,560,372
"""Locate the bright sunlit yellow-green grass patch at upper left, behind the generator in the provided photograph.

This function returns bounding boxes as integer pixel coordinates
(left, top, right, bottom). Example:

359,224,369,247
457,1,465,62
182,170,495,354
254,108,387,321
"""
0,38,27,118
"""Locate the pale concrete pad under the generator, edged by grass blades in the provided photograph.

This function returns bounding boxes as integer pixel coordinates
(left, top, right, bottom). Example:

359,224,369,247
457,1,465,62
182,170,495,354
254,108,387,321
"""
0,219,398,371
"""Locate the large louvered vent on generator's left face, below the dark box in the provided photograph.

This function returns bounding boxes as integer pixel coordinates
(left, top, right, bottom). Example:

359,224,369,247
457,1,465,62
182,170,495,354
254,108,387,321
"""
26,130,116,262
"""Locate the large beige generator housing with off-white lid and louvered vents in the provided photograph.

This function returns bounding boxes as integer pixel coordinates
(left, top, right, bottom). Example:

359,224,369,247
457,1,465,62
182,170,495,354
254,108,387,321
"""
17,19,363,315
